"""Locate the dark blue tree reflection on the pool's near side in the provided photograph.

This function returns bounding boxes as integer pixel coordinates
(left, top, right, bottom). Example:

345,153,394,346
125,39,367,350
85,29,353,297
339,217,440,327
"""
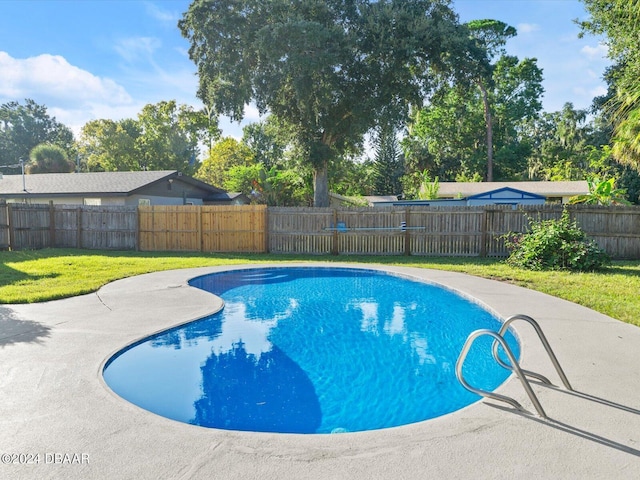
193,342,322,433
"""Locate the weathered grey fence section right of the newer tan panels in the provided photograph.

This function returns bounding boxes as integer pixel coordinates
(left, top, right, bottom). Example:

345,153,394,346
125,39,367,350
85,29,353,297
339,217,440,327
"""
268,205,640,259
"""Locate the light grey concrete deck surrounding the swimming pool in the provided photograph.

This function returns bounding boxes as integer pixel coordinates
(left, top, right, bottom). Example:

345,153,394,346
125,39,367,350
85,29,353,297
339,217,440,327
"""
0,263,640,480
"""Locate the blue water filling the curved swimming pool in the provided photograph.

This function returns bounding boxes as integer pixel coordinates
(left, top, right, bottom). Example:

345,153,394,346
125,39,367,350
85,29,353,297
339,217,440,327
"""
104,267,519,433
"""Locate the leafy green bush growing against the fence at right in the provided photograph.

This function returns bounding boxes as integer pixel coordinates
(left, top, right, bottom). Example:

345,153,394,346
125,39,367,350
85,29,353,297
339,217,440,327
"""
505,210,609,271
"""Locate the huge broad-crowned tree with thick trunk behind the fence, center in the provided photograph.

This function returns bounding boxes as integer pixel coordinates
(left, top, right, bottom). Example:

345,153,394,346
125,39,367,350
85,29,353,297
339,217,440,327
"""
179,0,468,206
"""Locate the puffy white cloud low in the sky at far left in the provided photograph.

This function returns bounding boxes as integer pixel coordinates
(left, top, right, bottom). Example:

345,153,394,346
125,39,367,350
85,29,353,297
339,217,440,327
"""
0,52,131,105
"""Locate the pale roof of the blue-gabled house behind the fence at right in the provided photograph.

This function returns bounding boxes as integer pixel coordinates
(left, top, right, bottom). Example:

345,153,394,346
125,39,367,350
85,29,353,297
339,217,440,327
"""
438,180,589,198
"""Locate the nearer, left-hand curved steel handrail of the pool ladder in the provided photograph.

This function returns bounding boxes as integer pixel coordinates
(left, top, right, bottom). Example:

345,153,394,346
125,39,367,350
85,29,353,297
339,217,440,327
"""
456,329,547,418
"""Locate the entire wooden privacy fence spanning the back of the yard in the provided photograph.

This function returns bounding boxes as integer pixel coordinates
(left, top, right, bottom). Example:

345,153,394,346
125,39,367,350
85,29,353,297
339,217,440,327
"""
0,204,640,259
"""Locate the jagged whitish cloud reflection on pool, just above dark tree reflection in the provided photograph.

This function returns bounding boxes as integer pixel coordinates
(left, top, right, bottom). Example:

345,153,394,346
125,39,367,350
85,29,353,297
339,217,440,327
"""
211,299,298,358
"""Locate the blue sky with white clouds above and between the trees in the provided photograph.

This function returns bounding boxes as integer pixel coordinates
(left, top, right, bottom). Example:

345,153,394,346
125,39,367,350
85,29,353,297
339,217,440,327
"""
0,0,609,137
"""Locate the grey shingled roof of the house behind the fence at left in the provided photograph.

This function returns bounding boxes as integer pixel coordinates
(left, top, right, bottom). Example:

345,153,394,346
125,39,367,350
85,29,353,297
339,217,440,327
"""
0,170,223,197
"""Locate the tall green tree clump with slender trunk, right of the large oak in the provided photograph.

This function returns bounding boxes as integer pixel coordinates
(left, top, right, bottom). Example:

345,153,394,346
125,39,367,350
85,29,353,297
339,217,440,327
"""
402,27,543,183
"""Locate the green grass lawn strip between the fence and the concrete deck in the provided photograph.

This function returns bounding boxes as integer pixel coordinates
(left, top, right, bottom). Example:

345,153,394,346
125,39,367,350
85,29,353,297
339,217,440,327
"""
0,249,640,326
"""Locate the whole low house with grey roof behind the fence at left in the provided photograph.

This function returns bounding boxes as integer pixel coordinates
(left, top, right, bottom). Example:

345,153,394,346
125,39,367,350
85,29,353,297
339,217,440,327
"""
0,170,248,205
